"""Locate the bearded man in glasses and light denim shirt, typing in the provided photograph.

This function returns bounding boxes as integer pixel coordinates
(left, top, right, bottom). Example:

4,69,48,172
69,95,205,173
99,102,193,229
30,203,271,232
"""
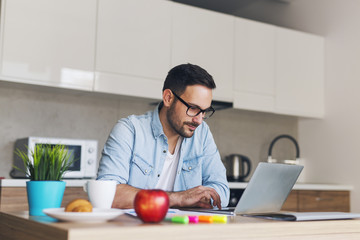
97,64,229,208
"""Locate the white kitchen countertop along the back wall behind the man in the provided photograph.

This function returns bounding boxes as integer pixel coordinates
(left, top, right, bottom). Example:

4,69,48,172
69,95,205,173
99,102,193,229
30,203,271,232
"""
0,179,353,191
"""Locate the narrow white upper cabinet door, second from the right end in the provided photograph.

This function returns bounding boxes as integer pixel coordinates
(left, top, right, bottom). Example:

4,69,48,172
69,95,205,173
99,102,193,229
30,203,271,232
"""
234,18,275,112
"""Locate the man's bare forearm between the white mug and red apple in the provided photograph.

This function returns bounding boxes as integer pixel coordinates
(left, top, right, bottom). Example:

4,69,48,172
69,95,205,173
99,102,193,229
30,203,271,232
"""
112,184,141,209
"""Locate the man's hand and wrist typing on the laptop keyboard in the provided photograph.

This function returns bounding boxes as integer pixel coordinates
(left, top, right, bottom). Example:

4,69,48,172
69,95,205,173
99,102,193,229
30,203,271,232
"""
169,186,221,209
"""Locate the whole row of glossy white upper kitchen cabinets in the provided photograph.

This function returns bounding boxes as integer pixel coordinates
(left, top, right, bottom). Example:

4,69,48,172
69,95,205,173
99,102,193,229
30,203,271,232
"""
0,0,324,118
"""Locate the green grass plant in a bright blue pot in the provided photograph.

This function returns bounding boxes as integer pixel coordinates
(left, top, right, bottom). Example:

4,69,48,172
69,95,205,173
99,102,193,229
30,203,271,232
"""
14,144,75,216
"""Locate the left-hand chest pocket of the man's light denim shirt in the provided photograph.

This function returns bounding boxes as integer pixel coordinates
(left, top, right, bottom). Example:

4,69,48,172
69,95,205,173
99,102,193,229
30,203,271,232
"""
128,154,153,188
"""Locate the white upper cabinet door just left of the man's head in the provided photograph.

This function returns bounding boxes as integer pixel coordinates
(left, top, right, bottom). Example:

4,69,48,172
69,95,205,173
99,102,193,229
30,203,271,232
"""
94,0,171,99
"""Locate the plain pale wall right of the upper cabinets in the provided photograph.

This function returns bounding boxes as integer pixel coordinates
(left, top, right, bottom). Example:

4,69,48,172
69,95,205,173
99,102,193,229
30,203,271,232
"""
238,0,360,212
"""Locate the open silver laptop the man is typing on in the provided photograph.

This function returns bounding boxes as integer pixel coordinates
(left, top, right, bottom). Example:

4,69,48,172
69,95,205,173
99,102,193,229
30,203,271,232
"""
181,162,304,215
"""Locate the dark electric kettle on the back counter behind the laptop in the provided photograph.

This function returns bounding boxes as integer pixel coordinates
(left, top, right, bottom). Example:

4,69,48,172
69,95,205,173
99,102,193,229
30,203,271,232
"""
225,154,251,182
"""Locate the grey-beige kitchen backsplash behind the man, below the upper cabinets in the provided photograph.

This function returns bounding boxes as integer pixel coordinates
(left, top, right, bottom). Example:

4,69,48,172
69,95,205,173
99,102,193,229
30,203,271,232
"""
0,81,301,177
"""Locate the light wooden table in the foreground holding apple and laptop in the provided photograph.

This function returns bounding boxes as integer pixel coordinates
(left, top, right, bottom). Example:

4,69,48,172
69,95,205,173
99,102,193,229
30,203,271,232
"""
0,212,360,240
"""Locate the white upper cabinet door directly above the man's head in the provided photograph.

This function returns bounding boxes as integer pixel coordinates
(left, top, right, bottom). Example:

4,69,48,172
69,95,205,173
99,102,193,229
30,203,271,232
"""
171,3,235,102
